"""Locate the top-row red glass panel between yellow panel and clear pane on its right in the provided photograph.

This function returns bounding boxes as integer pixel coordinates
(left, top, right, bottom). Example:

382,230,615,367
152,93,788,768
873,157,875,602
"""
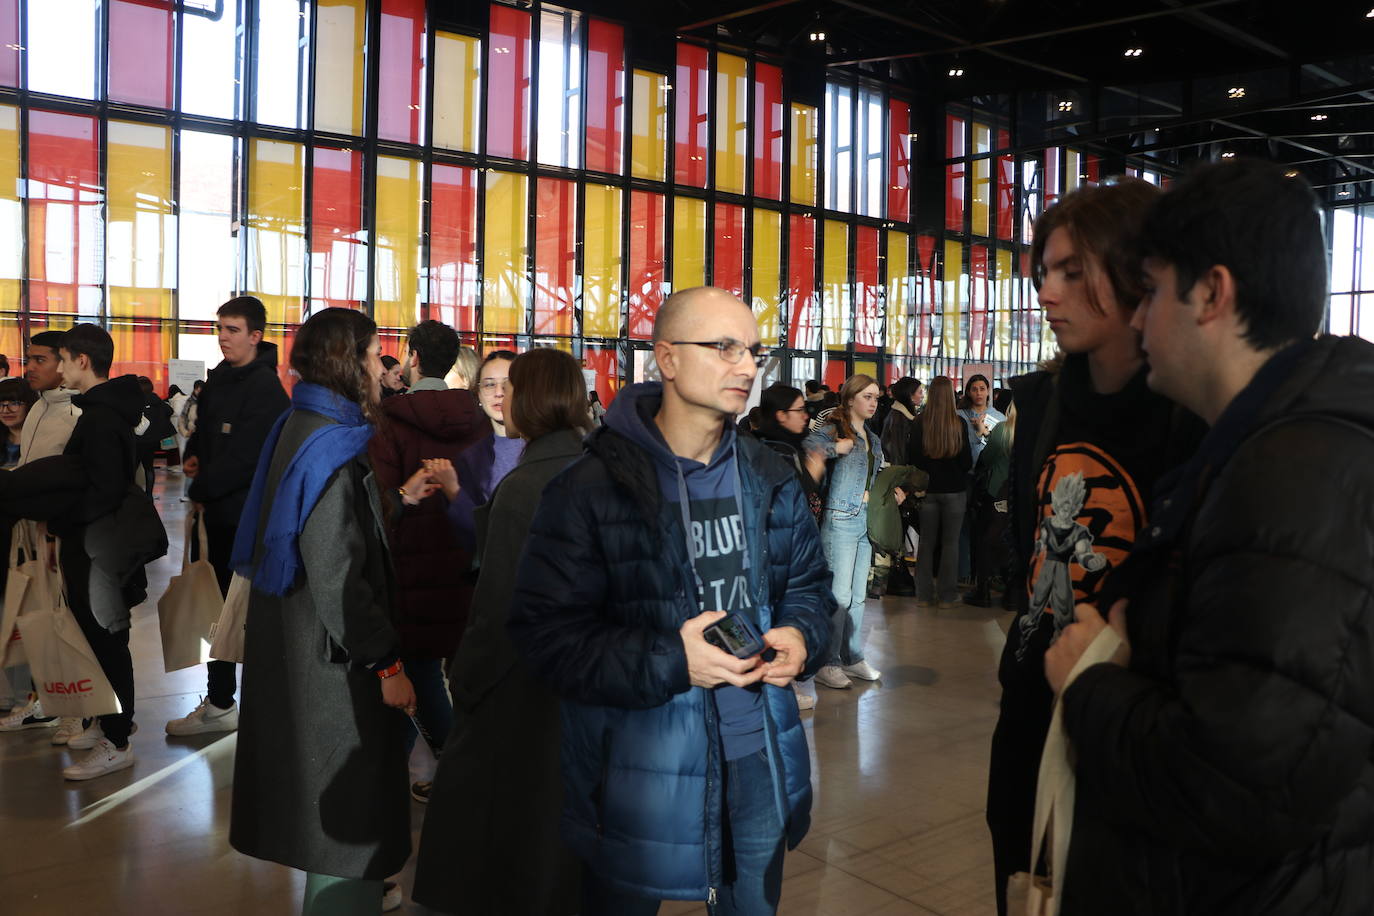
486,3,530,159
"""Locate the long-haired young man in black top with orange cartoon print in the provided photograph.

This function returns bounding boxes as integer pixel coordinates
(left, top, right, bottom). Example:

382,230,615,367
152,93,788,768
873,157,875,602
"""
988,179,1201,916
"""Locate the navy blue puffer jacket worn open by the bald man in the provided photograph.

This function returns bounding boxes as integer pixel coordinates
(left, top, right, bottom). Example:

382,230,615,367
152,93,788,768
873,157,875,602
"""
510,395,834,900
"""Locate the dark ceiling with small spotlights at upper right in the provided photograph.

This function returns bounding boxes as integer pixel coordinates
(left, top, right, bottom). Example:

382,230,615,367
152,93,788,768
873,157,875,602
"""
497,0,1374,202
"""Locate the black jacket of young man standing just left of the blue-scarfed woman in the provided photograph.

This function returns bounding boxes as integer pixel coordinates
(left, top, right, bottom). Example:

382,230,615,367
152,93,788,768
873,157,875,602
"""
185,341,291,527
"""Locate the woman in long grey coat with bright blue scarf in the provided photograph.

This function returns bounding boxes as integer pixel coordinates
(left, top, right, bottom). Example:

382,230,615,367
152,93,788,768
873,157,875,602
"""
229,309,423,916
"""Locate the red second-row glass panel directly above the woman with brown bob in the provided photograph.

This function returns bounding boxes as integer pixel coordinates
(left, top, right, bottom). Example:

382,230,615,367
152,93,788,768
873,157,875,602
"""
534,179,577,336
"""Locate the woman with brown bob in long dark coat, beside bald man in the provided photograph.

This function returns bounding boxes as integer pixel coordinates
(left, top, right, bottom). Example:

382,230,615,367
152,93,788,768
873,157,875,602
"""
414,349,591,916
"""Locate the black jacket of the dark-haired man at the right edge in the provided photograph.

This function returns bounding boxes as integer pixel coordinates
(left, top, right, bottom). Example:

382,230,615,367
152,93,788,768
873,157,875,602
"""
1061,338,1374,916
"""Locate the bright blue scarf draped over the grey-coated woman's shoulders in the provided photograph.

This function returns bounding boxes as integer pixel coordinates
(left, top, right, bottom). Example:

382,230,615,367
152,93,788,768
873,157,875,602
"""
229,382,372,595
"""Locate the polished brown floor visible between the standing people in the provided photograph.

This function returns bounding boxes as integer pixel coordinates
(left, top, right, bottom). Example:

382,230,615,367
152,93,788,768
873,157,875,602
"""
0,472,1009,916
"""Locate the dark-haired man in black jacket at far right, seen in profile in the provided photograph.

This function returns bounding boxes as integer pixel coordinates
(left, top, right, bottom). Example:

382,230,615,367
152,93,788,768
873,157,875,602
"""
1046,161,1374,916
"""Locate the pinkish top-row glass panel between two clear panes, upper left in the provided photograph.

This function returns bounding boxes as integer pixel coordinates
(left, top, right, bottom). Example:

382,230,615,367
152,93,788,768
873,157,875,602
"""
106,0,174,108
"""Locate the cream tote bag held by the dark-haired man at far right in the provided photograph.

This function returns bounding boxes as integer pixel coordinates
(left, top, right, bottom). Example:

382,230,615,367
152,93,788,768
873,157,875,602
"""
1007,626,1121,916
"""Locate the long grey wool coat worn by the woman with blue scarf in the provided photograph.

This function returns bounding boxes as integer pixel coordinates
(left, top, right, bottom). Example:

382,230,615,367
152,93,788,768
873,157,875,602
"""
229,411,411,879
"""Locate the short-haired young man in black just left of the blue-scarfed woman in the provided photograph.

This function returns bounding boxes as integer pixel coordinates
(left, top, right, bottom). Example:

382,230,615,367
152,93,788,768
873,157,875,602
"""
166,295,291,737
